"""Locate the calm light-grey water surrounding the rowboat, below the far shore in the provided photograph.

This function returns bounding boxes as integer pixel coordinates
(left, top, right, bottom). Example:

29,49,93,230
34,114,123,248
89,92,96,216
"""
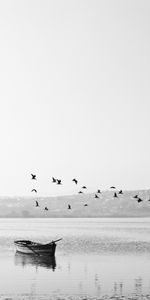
0,218,150,300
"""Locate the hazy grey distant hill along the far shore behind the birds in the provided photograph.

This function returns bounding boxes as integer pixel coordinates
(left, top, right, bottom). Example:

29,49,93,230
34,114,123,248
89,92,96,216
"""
0,190,150,218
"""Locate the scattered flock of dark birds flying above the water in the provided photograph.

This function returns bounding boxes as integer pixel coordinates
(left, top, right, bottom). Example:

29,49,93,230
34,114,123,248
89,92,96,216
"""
31,174,150,211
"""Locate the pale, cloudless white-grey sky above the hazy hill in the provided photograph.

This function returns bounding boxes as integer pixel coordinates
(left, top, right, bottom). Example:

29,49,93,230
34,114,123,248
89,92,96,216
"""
0,0,150,196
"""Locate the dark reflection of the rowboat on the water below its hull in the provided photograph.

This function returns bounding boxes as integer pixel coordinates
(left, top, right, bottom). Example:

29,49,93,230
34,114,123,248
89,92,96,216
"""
14,252,56,271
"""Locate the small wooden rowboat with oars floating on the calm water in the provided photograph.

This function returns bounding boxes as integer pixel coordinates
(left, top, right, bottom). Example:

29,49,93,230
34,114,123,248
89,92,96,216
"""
14,239,62,256
